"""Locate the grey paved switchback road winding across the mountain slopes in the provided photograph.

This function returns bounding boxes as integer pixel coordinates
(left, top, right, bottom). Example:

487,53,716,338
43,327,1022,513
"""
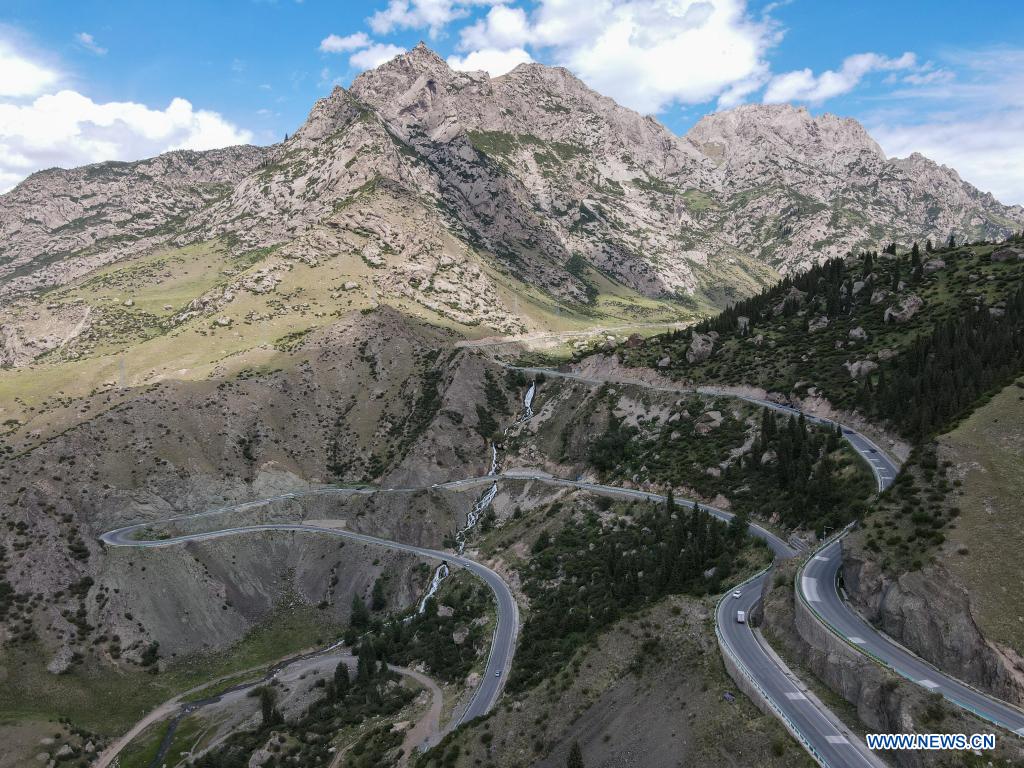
100,366,1024,768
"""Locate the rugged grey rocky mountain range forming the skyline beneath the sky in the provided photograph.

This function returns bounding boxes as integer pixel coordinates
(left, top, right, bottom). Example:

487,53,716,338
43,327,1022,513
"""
0,44,1024,366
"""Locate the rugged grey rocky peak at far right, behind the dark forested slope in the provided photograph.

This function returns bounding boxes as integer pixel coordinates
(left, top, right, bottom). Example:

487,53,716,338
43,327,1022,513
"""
687,104,1024,271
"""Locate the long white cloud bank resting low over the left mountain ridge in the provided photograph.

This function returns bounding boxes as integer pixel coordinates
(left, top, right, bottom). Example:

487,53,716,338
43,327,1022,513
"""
0,90,252,190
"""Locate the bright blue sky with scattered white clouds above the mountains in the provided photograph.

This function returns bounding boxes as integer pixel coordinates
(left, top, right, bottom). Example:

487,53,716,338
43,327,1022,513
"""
0,0,1024,203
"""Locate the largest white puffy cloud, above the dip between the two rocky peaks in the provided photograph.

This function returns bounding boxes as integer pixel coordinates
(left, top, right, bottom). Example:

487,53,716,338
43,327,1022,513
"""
450,0,777,113
